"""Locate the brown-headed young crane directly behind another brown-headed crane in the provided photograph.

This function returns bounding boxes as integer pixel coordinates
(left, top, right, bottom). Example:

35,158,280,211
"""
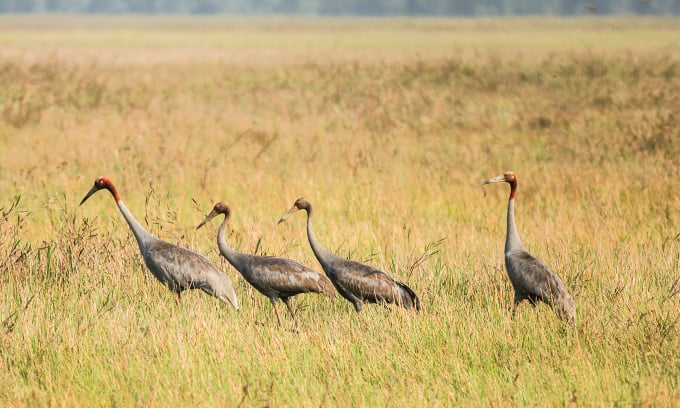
279,198,420,313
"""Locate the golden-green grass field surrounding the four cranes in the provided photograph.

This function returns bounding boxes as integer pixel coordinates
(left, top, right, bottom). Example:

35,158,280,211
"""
0,16,680,406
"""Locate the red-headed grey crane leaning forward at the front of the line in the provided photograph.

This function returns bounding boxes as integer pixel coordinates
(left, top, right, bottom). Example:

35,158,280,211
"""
80,177,238,310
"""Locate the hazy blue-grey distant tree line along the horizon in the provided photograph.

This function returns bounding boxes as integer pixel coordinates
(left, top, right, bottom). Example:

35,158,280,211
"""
0,0,680,16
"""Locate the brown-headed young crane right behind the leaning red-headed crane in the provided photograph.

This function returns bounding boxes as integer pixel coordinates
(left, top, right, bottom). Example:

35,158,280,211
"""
196,202,335,325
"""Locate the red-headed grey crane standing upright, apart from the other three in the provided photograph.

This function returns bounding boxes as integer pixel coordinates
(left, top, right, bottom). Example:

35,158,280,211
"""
482,171,576,323
